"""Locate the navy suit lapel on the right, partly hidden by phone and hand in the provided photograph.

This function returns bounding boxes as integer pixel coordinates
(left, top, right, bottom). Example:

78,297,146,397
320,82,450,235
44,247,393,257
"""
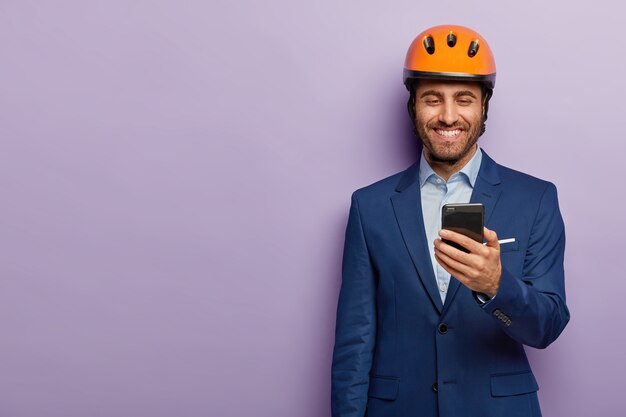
442,151,502,314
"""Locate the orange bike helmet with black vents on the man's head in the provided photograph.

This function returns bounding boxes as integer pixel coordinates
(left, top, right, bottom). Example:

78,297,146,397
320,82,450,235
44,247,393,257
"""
404,25,496,89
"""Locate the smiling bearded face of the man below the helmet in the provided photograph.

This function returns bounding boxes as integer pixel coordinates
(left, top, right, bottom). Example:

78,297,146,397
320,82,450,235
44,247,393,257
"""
415,80,483,165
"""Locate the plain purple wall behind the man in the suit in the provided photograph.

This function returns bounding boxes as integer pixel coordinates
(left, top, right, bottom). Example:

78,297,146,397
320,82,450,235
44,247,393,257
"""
0,0,626,417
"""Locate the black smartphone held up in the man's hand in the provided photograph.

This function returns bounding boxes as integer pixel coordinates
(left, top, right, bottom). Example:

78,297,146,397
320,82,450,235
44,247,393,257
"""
441,203,485,252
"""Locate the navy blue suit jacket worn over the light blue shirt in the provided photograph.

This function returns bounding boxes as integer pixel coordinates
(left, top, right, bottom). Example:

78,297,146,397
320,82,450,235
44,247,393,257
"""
331,153,569,417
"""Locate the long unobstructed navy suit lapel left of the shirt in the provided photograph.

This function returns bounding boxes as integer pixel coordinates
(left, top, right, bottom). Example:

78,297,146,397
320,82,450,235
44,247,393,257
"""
391,160,443,313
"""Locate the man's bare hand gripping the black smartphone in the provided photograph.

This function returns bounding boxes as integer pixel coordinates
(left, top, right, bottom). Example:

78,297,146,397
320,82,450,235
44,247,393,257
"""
435,227,502,297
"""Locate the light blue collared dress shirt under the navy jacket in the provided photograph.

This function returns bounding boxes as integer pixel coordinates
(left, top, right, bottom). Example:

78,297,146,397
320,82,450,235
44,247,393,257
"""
419,145,483,302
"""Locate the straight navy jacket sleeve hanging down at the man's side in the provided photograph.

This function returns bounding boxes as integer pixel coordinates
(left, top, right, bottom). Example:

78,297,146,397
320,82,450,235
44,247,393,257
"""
331,194,376,417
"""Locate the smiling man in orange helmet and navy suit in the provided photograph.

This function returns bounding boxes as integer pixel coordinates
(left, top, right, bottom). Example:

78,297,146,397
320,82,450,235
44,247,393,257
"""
332,25,569,417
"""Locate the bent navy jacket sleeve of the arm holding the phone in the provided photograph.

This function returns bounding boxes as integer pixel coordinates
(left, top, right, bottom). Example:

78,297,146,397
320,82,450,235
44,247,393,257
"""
483,184,570,349
